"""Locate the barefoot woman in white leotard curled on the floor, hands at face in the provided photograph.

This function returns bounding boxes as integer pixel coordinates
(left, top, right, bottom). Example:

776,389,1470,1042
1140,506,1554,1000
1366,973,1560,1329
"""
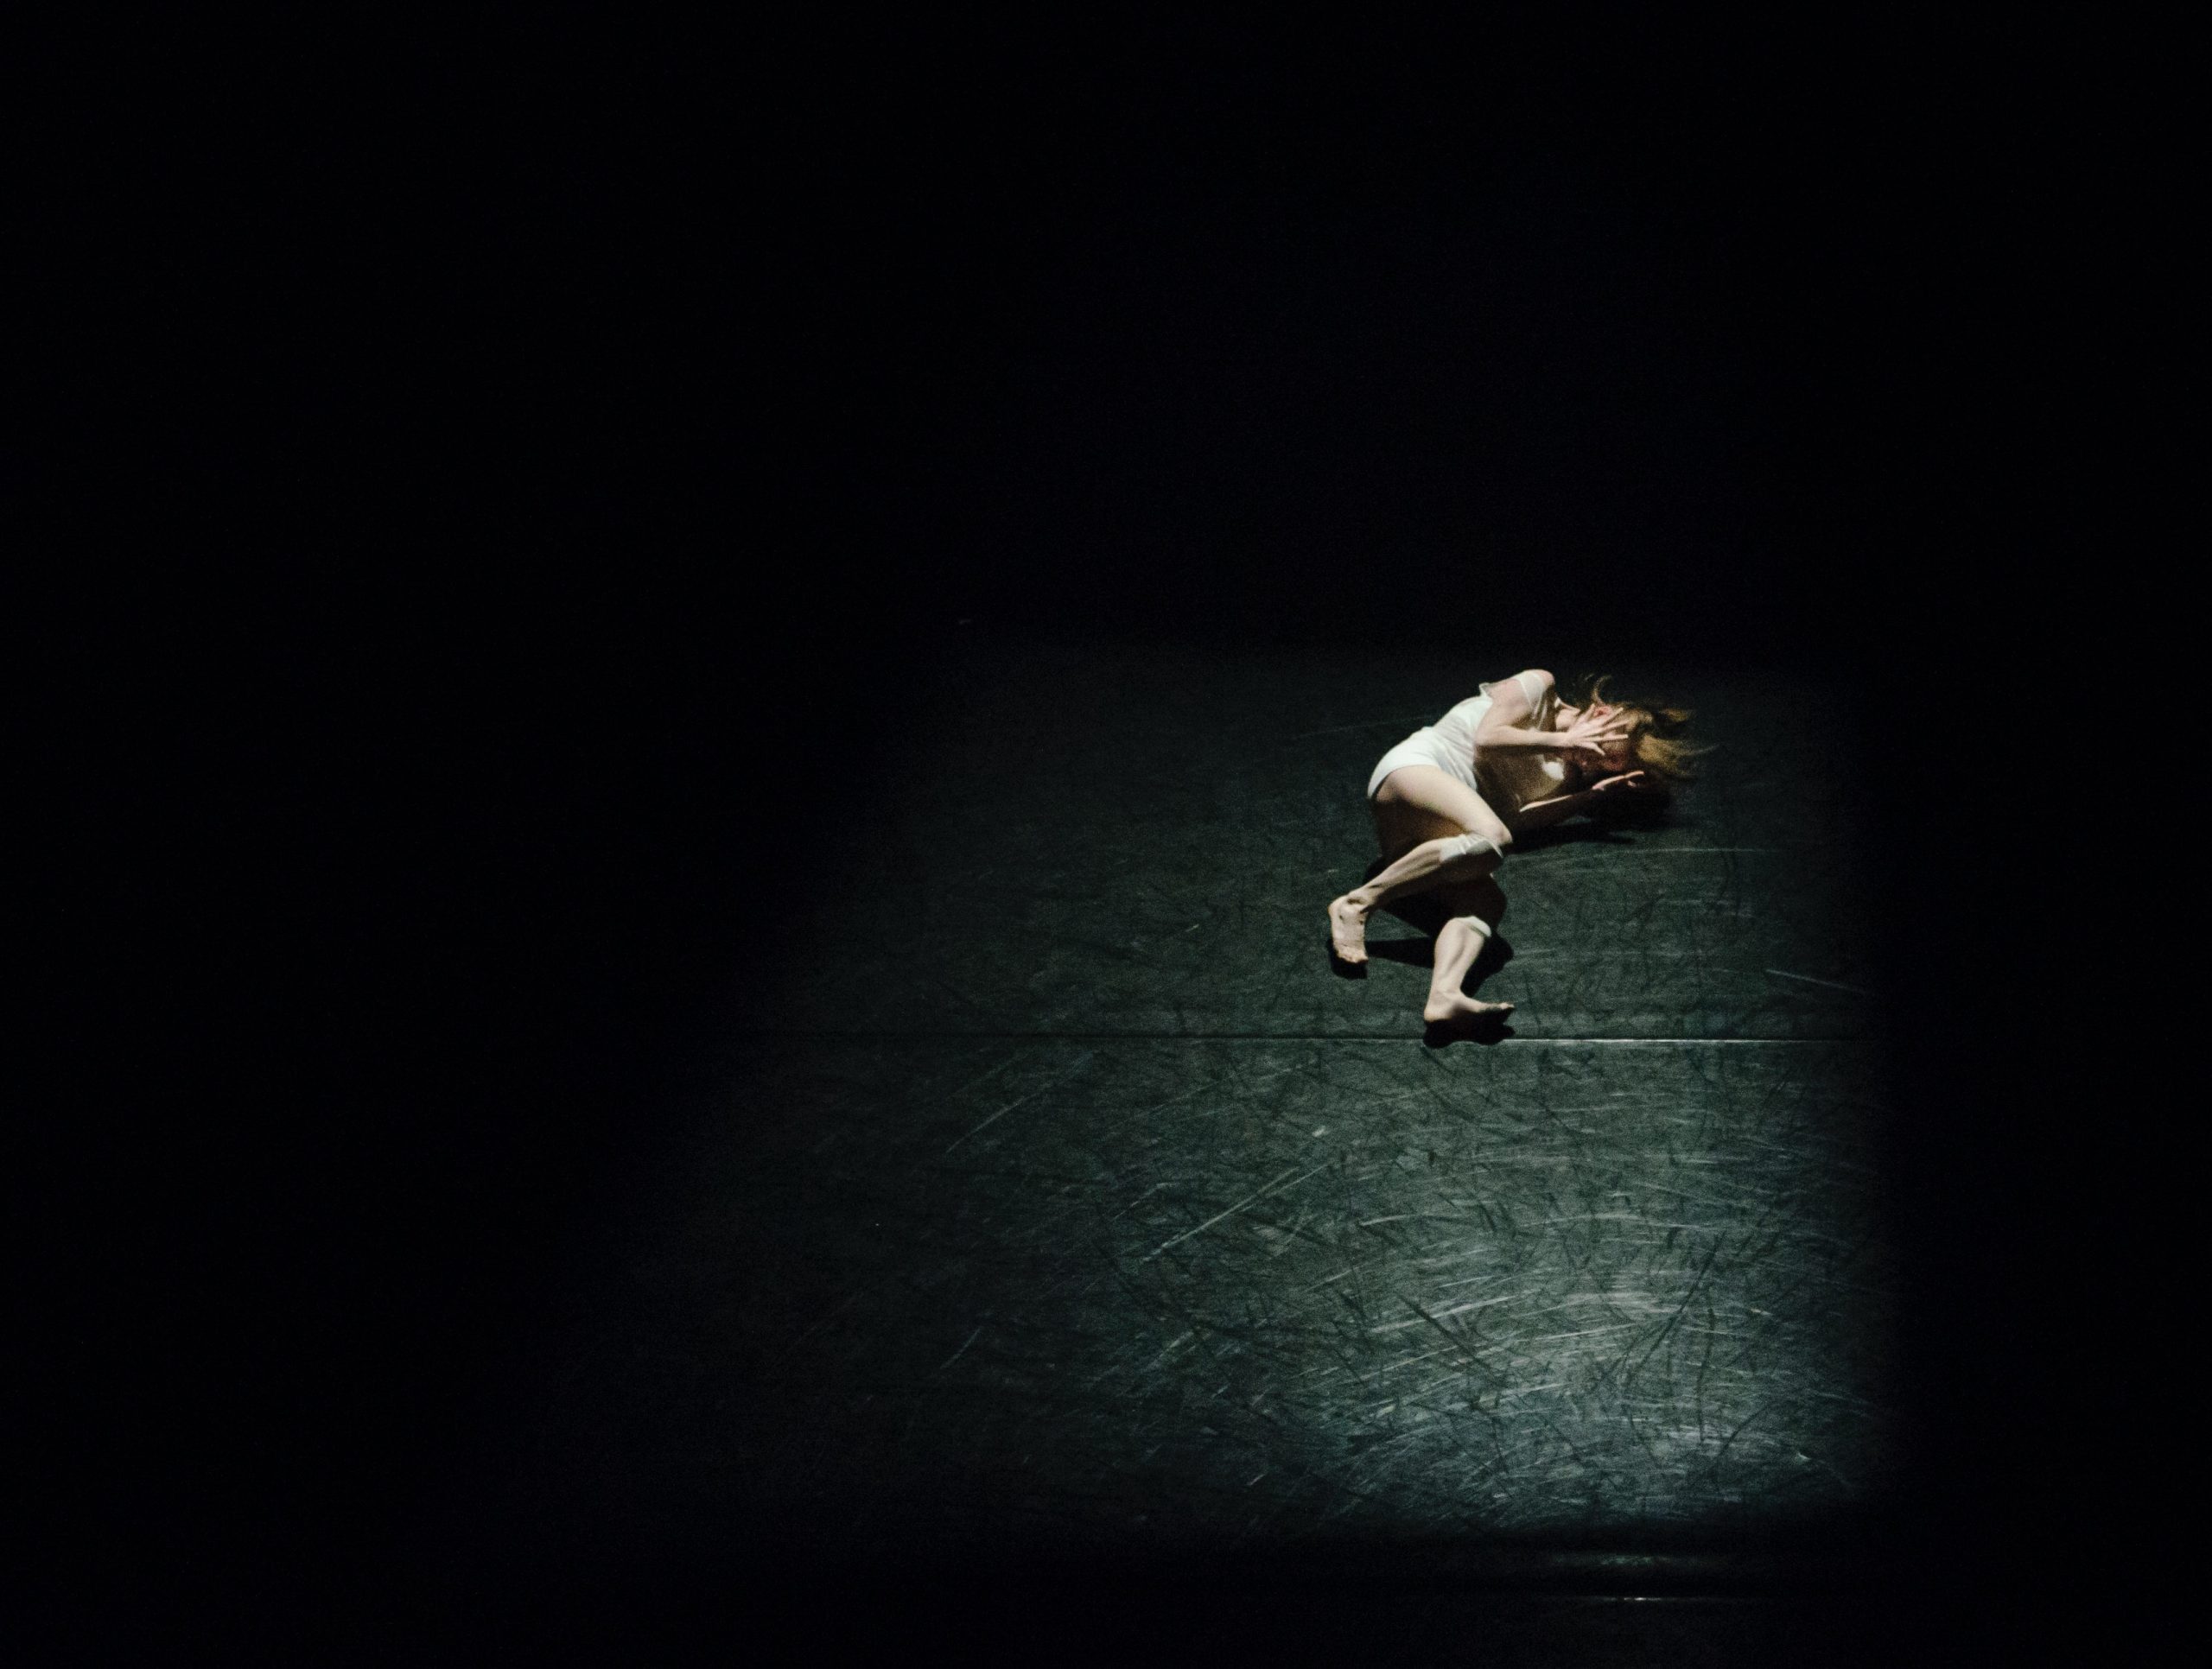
1330,670,1694,1025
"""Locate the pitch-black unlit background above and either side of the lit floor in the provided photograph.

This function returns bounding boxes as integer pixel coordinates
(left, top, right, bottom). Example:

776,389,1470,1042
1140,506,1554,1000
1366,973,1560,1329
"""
27,17,2170,1662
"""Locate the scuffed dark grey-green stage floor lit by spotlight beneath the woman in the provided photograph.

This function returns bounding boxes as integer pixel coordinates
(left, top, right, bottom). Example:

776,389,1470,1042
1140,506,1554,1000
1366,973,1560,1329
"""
422,639,1904,1662
